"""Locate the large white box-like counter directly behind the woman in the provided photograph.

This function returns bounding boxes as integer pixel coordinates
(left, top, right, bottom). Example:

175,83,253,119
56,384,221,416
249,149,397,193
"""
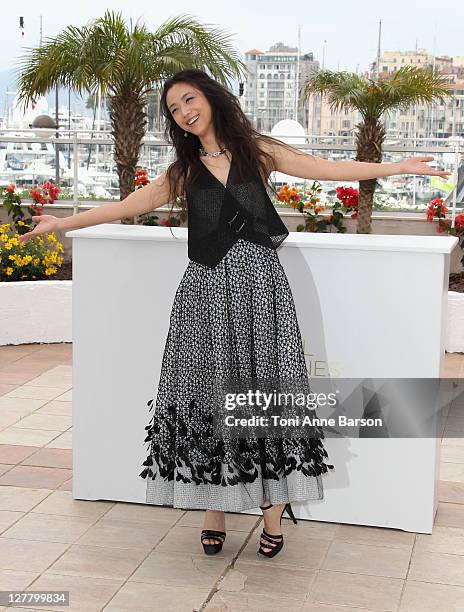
66,224,457,533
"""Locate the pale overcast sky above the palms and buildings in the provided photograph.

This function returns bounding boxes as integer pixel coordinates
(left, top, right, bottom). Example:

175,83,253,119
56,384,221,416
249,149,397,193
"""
0,0,464,72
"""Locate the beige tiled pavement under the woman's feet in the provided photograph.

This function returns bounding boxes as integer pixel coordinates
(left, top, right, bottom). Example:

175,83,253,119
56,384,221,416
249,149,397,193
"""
0,344,464,612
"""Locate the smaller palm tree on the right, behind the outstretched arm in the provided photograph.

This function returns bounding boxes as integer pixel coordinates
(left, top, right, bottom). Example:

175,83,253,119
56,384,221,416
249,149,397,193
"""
302,66,449,234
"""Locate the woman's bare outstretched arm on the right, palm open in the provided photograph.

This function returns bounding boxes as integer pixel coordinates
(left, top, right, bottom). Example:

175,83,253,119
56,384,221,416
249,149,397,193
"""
260,141,451,181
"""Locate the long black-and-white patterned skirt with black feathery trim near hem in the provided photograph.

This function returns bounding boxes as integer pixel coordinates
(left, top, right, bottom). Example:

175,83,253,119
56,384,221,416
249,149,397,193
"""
140,239,334,512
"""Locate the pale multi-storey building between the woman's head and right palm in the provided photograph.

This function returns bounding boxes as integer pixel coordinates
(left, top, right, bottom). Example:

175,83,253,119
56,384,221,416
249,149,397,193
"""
242,42,319,132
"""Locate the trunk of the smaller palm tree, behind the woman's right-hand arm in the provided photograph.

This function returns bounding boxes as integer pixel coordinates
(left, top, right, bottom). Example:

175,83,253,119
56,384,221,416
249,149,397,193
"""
356,119,385,234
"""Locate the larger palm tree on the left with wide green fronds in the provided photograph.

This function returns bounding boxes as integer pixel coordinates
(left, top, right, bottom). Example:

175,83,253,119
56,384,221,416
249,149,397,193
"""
18,11,246,220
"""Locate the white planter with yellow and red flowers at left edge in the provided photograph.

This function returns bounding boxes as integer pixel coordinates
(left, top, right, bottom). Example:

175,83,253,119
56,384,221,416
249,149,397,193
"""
0,182,72,345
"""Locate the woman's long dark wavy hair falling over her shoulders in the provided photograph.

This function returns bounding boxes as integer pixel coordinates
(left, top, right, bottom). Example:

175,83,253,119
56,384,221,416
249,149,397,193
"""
156,69,294,230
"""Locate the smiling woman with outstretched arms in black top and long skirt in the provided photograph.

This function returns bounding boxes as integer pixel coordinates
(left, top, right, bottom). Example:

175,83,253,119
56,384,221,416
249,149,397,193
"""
20,70,449,557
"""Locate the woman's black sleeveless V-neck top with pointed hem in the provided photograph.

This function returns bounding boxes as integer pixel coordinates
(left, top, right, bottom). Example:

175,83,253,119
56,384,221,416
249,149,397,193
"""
186,157,289,268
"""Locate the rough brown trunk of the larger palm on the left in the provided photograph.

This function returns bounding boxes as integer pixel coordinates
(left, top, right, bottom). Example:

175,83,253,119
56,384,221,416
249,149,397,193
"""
110,92,147,223
